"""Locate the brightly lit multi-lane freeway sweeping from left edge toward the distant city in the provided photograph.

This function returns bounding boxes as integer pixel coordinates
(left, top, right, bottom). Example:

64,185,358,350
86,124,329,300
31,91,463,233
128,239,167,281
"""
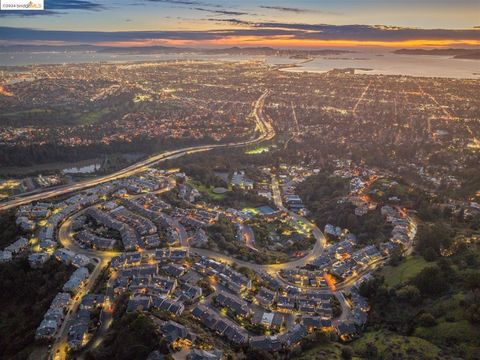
0,90,275,211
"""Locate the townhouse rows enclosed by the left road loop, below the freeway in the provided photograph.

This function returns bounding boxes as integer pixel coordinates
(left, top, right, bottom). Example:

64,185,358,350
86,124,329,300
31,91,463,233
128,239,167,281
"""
73,174,220,251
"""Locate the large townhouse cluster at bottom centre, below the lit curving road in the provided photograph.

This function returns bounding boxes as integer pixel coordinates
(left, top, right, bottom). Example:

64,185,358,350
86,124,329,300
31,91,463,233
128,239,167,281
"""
104,248,338,350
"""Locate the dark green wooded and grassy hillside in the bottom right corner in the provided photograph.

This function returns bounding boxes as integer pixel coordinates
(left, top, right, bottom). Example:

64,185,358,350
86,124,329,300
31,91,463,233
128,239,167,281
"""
360,240,480,360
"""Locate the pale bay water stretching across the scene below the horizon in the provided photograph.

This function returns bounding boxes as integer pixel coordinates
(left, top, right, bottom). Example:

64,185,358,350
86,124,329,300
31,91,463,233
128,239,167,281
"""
0,52,479,80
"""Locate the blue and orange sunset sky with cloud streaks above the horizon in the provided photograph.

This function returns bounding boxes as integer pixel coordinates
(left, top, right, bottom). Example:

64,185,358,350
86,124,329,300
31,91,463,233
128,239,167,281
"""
0,0,480,48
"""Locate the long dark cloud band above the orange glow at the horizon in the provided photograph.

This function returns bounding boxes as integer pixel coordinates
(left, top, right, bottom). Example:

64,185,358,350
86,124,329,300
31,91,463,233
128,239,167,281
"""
0,22,480,43
